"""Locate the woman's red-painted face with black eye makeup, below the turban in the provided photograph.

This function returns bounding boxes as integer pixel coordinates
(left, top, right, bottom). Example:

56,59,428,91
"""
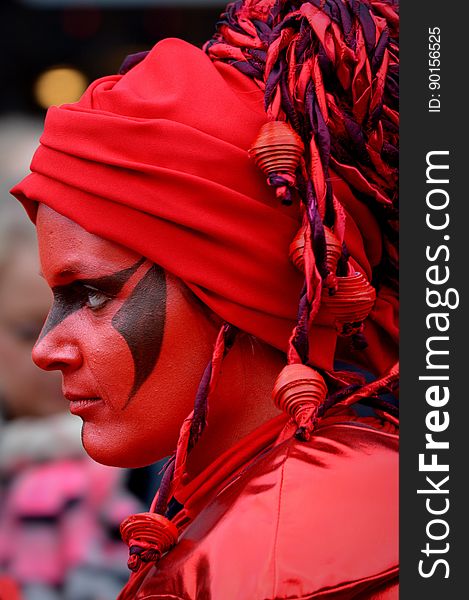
33,205,218,467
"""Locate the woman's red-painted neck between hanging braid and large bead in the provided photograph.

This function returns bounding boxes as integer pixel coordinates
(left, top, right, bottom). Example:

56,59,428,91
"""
187,334,285,479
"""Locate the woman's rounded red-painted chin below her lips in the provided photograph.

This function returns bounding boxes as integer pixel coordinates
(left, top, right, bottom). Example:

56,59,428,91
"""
81,423,170,469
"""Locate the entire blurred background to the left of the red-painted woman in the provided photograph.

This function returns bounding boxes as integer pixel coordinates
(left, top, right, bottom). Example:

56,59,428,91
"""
0,0,225,600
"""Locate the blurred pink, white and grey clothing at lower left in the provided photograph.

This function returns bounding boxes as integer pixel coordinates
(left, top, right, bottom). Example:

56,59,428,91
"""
0,415,140,600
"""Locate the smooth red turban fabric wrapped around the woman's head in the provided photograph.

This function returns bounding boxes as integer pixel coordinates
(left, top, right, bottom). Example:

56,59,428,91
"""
12,39,396,371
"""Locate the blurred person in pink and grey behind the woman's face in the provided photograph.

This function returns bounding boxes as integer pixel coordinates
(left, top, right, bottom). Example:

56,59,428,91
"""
0,117,144,600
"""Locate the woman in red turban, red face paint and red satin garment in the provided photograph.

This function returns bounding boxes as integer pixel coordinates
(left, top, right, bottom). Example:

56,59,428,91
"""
9,0,398,599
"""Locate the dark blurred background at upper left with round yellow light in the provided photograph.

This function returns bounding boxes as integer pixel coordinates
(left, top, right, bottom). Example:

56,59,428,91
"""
0,0,224,116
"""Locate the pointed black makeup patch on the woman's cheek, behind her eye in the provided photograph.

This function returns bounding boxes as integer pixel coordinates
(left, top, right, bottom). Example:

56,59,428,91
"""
112,265,166,406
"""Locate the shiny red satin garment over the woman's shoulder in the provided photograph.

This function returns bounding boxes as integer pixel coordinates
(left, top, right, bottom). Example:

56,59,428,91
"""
119,415,398,600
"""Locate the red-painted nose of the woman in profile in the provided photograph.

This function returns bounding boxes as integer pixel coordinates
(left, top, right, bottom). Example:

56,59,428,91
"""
32,327,83,372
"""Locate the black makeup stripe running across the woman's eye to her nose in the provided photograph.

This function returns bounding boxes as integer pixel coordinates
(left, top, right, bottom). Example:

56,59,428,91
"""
38,257,146,341
